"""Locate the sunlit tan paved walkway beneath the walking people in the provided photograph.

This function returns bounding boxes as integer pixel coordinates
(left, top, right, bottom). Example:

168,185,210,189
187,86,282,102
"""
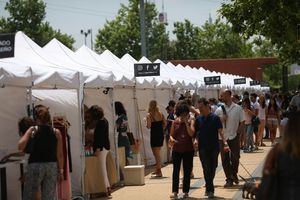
98,142,271,200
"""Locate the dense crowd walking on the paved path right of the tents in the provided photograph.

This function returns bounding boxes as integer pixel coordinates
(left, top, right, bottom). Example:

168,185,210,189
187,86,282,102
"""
166,85,300,199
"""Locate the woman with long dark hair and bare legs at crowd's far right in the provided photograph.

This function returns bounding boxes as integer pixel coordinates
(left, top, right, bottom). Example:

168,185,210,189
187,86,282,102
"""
266,96,280,145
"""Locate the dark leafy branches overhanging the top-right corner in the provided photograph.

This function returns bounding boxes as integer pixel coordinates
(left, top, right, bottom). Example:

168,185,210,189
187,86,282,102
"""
220,0,300,63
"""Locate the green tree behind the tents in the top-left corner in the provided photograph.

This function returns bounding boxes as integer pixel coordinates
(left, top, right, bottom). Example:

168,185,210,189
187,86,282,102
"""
0,0,75,49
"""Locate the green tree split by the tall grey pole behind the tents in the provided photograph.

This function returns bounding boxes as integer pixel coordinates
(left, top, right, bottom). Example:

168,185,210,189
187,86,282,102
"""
95,0,169,60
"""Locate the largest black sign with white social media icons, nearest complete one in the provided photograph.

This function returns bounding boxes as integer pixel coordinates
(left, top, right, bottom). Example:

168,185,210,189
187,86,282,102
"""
134,63,160,77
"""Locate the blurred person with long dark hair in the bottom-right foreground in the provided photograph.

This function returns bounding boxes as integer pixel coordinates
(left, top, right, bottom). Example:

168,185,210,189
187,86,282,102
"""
257,111,300,200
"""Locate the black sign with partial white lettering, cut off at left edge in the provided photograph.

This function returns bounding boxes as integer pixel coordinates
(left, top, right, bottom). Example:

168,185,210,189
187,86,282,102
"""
0,33,15,58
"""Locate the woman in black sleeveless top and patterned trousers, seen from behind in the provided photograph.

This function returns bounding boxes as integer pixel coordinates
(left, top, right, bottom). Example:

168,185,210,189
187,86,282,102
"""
19,105,64,200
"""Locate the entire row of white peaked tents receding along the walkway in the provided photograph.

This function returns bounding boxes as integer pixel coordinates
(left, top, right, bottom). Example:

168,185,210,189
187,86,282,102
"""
0,32,267,199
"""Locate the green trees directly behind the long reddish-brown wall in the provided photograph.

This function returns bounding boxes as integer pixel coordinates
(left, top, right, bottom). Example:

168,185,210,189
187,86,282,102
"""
173,19,253,59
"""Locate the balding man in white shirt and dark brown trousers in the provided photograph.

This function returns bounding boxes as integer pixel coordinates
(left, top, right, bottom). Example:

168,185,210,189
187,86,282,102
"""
215,90,244,187
